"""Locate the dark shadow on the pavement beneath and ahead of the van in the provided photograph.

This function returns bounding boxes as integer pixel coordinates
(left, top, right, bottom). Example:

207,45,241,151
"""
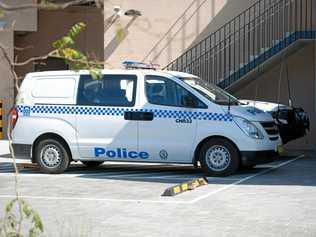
0,156,316,186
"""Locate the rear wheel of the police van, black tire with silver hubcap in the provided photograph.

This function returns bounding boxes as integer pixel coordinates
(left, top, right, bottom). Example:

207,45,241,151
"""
34,139,70,174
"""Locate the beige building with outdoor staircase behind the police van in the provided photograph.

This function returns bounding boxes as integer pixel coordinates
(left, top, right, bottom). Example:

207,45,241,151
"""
0,0,316,150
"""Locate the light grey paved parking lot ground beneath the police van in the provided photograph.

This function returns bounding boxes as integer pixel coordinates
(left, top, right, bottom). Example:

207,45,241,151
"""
0,142,316,237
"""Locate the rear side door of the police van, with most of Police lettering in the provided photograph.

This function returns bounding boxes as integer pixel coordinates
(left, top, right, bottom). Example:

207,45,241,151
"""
76,73,141,160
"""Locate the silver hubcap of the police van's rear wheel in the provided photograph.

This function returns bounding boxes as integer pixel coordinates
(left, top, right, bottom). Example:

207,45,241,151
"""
41,144,62,168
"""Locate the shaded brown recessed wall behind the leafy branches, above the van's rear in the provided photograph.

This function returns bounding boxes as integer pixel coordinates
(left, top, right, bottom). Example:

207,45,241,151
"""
15,7,103,76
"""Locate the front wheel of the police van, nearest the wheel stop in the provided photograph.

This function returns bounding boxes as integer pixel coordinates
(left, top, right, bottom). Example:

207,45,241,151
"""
199,138,240,176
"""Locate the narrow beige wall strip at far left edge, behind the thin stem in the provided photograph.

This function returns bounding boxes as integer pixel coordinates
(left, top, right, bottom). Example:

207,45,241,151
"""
0,30,14,139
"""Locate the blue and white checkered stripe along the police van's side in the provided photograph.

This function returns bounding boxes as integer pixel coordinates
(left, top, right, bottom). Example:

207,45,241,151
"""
18,105,233,122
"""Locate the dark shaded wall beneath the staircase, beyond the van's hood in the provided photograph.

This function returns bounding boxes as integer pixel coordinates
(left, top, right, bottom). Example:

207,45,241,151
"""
233,43,316,150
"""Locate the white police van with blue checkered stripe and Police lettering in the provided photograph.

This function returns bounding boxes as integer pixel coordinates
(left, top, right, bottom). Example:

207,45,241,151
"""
11,63,282,176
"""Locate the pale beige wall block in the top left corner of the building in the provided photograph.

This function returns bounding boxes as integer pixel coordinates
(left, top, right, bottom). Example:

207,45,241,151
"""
0,0,37,31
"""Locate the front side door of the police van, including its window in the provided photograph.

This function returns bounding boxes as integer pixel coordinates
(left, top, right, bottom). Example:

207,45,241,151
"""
139,75,207,163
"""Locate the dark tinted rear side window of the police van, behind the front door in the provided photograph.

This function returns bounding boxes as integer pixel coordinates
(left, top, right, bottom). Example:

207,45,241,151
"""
77,75,137,107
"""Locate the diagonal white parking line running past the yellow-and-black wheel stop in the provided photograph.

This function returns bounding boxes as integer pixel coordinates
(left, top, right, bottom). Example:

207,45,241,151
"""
189,155,304,204
